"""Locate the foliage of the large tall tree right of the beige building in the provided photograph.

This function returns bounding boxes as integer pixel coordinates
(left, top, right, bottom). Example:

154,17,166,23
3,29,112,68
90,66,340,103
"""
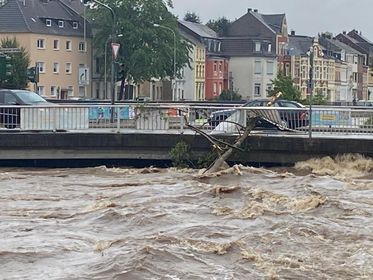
87,0,191,83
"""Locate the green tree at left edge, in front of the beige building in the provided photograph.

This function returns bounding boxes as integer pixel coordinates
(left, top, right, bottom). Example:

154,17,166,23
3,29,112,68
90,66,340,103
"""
0,38,30,89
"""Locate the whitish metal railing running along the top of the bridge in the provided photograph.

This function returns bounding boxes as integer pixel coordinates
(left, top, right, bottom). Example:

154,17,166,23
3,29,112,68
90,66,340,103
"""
0,103,373,136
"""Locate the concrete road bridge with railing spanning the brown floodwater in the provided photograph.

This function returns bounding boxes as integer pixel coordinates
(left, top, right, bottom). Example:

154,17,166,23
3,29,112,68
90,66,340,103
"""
0,105,373,167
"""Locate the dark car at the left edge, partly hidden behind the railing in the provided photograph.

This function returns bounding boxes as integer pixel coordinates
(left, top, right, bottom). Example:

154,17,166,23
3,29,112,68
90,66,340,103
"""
0,89,51,128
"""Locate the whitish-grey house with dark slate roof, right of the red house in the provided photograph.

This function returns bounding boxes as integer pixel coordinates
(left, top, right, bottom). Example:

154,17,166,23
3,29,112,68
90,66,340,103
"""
221,9,288,99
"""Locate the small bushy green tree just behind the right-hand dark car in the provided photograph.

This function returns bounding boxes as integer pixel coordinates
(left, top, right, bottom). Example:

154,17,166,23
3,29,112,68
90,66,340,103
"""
268,71,301,101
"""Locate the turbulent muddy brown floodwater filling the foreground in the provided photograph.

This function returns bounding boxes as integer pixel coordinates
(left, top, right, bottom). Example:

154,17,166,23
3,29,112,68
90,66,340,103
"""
0,155,373,280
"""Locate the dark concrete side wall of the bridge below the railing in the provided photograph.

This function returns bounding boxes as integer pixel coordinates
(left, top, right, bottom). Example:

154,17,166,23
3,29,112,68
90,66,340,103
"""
0,132,373,167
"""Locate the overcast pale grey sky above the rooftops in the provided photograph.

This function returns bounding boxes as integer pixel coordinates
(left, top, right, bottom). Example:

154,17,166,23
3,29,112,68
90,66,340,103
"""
172,0,373,41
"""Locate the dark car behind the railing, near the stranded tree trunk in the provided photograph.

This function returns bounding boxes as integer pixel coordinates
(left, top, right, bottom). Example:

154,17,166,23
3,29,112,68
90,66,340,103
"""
208,99,308,129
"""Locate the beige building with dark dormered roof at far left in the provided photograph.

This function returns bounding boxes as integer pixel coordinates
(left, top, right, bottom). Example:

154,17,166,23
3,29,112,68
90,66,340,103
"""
0,0,92,99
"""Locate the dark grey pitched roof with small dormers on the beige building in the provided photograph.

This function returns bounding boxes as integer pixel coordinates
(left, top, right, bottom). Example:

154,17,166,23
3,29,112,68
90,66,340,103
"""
0,0,91,37
